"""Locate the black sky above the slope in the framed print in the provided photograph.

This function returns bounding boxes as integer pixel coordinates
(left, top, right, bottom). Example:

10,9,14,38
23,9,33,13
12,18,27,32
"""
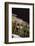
12,8,29,24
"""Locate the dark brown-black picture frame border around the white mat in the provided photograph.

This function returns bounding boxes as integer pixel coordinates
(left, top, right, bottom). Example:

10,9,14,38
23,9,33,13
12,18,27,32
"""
5,2,34,44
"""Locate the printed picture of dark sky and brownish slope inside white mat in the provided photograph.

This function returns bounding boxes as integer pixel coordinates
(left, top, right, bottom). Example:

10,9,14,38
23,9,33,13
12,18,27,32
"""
12,8,29,38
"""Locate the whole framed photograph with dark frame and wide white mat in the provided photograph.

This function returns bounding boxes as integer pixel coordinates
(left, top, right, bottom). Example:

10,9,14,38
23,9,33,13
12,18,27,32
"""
5,2,34,44
